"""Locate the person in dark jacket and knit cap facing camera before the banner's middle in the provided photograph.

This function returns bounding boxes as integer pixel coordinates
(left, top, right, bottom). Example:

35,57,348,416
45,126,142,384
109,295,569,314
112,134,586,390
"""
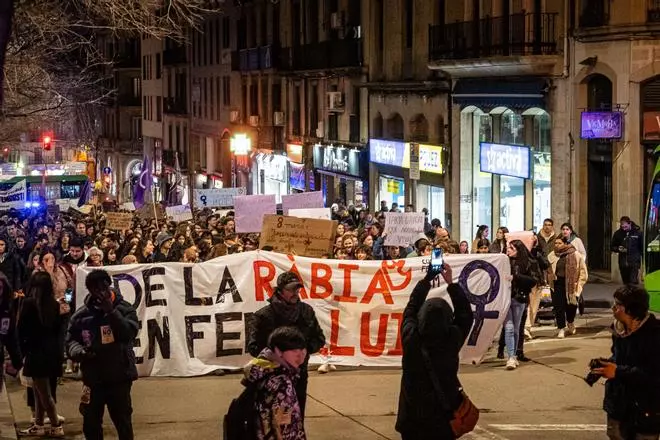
248,272,325,417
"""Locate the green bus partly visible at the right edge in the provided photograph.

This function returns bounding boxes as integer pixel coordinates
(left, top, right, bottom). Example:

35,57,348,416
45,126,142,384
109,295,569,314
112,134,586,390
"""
644,145,660,312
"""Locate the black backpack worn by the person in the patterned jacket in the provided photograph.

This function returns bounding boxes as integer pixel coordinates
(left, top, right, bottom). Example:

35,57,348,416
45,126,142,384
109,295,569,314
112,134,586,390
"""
222,377,268,440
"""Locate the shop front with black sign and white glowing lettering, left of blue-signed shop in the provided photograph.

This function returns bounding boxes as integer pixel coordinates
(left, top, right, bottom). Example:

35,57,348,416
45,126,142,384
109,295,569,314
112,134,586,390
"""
310,144,369,207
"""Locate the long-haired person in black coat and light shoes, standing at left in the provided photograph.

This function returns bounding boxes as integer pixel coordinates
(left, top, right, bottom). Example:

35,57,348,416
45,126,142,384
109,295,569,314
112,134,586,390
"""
18,272,64,437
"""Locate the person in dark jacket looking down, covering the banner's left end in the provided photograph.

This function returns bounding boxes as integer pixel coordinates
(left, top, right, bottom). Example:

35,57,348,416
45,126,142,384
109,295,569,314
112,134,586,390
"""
66,269,139,440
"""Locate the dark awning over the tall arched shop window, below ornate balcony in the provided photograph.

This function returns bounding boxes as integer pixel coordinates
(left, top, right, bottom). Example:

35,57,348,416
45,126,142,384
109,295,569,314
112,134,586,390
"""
452,77,548,110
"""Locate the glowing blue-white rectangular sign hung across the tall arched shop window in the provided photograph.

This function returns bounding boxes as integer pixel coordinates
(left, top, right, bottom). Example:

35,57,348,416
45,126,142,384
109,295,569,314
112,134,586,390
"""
479,142,531,179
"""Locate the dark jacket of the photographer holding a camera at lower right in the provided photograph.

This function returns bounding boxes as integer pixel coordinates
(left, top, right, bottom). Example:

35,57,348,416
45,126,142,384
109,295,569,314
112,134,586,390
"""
603,315,660,434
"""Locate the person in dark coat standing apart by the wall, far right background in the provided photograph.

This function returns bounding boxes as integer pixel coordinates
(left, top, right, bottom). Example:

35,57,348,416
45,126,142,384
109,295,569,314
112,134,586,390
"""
611,216,644,284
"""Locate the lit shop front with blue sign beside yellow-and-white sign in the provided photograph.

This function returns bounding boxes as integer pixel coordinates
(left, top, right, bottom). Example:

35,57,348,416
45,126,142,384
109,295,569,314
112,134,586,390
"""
369,139,447,224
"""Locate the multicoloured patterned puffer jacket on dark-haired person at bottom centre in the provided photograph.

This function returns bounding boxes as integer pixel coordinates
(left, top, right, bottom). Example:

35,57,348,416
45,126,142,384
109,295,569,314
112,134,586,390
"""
244,348,307,440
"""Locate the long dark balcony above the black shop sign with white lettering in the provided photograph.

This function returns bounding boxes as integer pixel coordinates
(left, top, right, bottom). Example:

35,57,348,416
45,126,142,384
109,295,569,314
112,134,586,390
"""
281,39,362,71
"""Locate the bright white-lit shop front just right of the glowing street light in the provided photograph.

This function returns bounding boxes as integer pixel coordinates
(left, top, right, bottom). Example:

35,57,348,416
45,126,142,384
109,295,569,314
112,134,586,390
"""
251,151,289,203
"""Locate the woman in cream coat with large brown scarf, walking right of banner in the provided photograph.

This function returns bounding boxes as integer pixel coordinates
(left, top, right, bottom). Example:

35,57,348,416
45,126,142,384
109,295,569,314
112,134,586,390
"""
548,237,589,339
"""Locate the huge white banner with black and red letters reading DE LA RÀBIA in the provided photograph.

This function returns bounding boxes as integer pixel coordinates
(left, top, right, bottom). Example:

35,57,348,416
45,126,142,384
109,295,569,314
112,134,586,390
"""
76,251,511,376
